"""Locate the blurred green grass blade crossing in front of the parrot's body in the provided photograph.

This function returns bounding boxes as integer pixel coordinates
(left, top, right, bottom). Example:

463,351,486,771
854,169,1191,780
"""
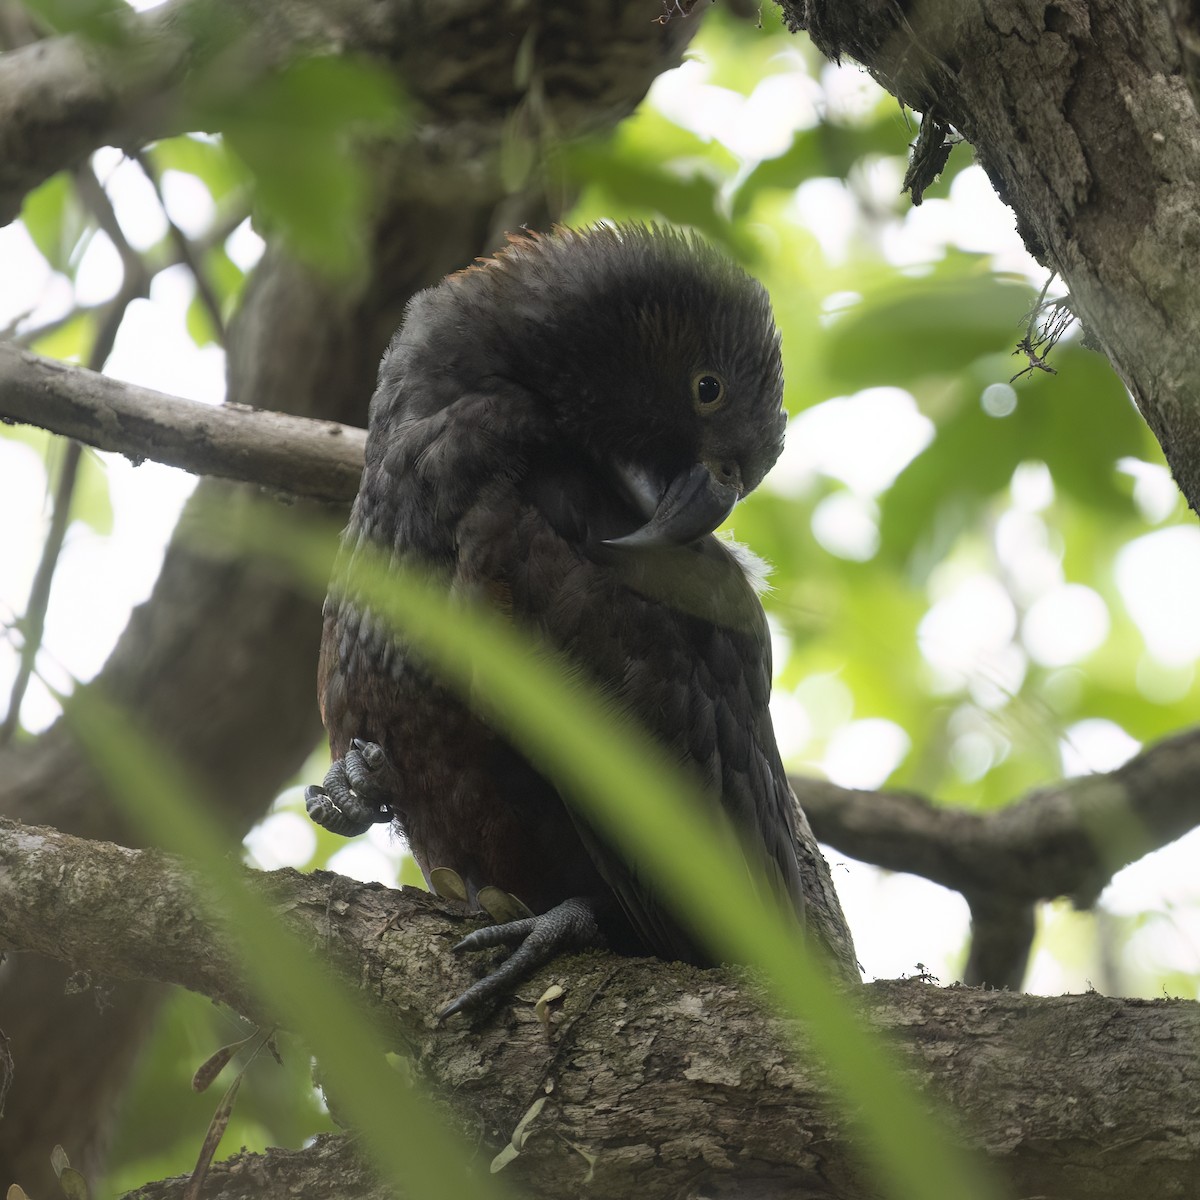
227,510,1006,1200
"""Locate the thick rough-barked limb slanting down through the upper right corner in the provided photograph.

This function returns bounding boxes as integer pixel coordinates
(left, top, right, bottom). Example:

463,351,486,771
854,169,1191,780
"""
779,0,1200,511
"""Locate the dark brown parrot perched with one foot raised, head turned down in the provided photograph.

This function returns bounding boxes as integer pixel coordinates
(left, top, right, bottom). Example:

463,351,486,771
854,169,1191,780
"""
307,226,804,1013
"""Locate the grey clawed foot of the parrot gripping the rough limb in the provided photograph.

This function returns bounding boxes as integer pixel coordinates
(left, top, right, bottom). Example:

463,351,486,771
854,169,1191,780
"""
438,896,605,1020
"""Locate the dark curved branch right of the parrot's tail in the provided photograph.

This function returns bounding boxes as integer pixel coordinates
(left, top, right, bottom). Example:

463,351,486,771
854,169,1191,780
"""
792,730,1200,907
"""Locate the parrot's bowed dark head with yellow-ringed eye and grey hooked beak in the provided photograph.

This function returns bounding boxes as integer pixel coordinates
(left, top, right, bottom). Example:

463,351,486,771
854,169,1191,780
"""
408,226,786,546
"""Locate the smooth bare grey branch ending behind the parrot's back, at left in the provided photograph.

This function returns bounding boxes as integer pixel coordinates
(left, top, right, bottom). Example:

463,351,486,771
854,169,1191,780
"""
0,343,366,502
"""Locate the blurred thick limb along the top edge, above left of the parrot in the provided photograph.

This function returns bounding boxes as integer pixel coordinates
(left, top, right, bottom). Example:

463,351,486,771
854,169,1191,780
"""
0,0,696,224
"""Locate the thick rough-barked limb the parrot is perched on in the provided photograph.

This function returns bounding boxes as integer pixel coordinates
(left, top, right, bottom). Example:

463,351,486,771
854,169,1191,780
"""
0,823,1200,1200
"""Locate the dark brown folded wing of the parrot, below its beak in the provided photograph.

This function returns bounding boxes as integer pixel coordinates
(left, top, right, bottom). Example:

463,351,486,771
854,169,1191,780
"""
496,451,804,962
